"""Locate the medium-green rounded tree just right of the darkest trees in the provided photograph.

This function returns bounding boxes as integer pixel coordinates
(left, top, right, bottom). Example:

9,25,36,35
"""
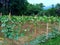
25,3,44,15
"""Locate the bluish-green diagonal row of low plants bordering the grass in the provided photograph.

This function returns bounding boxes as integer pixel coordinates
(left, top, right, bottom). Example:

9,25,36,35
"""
24,29,60,45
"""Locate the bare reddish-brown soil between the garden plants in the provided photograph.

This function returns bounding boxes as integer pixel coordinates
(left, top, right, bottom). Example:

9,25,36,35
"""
0,22,57,45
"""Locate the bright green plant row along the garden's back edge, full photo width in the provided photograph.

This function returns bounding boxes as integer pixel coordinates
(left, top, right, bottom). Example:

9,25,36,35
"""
0,16,60,22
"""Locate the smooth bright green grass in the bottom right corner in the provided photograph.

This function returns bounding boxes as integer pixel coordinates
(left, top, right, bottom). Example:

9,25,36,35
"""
39,35,60,45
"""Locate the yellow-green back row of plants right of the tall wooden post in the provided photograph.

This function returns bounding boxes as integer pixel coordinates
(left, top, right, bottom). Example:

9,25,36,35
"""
13,16,60,23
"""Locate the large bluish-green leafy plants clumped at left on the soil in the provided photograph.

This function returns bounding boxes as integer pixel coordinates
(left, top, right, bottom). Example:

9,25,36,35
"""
1,17,20,40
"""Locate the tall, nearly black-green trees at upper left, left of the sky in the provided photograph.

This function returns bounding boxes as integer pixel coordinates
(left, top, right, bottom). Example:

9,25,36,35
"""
0,0,28,15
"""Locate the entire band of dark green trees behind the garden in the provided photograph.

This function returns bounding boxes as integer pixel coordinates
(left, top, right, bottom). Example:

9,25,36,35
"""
0,0,60,16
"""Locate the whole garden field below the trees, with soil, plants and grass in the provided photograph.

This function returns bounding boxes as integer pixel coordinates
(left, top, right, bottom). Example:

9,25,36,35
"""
0,15,60,45
